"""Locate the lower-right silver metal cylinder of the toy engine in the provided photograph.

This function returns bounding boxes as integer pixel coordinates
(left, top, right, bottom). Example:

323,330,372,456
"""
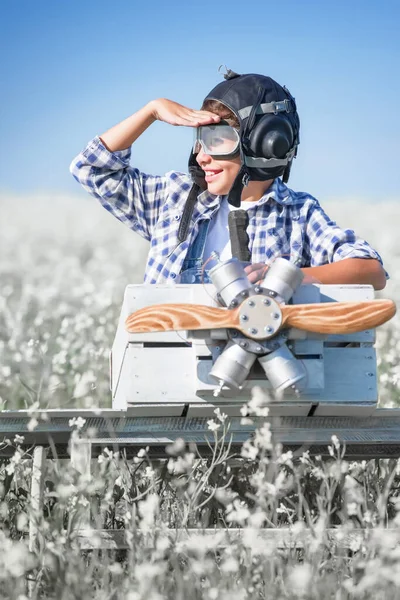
258,344,307,393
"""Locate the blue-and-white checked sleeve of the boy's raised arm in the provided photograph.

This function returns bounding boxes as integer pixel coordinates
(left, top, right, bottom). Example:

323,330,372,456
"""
70,137,167,240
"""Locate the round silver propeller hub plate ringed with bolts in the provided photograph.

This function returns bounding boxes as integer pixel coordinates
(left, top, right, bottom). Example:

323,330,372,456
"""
239,294,282,340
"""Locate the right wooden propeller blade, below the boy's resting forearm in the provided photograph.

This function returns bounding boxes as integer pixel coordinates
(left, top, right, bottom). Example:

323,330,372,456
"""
281,300,396,334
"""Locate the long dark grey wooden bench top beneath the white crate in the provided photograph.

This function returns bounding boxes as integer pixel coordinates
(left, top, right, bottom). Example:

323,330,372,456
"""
0,412,400,459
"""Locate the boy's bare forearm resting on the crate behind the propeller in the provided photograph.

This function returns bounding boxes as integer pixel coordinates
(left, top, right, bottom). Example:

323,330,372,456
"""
302,258,386,290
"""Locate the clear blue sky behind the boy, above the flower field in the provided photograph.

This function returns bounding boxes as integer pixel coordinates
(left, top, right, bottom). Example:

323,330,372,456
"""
0,0,400,201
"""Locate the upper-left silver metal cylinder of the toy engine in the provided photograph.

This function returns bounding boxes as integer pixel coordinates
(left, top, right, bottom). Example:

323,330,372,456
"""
210,258,252,306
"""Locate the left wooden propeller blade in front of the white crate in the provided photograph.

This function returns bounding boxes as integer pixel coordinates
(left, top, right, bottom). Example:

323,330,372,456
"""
125,304,240,333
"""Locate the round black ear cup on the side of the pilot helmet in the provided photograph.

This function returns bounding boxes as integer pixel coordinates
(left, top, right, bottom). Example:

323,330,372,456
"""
248,115,295,158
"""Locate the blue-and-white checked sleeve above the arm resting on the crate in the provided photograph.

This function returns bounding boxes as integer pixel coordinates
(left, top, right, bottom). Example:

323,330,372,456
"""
306,202,389,278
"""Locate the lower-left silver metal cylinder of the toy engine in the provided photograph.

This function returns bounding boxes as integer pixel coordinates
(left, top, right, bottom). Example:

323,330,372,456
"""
210,341,257,388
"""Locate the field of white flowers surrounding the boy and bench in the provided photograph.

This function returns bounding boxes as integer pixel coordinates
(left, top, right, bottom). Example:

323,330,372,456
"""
0,194,400,600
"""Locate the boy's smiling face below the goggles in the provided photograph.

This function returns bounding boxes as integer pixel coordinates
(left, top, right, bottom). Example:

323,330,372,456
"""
196,148,241,196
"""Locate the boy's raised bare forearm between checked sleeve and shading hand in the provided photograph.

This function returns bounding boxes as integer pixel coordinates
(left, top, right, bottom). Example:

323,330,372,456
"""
99,102,156,152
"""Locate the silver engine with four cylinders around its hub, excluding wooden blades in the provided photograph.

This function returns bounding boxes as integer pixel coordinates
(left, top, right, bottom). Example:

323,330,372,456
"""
210,253,307,396
